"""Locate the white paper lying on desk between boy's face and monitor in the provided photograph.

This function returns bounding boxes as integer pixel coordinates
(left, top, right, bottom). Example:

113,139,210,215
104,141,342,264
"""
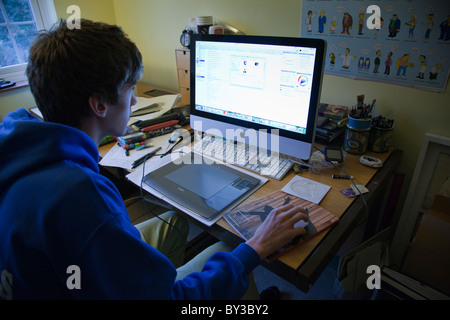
128,94,181,125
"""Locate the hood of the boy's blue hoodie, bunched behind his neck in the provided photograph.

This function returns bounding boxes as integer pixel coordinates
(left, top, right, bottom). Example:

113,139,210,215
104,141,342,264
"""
0,109,99,193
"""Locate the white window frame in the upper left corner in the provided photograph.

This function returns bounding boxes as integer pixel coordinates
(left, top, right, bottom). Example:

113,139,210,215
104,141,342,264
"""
0,0,58,82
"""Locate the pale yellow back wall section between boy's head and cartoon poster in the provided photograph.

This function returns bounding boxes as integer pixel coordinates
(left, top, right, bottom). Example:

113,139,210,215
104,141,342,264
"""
114,0,300,90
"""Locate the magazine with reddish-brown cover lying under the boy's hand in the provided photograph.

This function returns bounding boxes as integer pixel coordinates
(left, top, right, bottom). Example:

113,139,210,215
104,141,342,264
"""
223,190,339,262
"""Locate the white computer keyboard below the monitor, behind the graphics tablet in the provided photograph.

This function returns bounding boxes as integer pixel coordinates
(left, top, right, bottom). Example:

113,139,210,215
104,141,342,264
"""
192,136,293,180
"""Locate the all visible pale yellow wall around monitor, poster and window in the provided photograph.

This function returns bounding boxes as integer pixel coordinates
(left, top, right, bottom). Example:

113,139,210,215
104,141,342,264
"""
0,0,450,215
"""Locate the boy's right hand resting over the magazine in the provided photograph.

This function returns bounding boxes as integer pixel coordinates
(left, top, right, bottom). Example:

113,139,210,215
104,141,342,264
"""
246,204,308,260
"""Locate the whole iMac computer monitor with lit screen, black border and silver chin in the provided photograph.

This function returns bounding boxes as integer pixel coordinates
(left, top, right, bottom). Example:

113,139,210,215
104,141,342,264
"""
191,35,326,159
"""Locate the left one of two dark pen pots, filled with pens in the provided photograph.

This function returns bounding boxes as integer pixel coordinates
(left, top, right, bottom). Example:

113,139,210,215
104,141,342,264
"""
344,95,375,155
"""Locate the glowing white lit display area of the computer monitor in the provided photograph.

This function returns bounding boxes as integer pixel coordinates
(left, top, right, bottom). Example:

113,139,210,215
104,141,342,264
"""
194,41,316,134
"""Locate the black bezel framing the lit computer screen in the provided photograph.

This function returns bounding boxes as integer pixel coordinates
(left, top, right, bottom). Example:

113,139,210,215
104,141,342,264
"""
190,34,326,143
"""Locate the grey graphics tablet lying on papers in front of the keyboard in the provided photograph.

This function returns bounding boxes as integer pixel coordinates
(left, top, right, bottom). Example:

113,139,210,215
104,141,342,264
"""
144,153,260,220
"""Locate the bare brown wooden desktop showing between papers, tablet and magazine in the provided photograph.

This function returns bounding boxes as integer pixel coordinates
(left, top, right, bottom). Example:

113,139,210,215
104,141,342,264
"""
99,84,401,291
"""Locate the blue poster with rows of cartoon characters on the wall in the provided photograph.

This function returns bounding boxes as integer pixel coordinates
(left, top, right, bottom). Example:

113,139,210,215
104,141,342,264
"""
300,0,450,92
